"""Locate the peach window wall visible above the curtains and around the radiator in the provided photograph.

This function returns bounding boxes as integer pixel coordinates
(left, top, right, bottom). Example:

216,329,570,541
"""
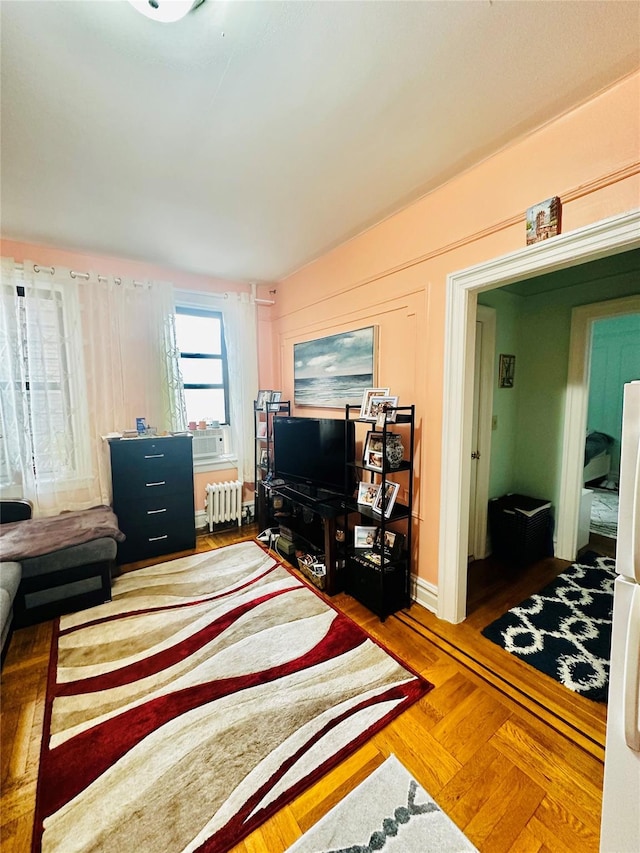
0,238,248,500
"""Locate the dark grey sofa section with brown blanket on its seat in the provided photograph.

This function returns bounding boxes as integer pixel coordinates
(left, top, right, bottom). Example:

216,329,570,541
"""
0,501,124,659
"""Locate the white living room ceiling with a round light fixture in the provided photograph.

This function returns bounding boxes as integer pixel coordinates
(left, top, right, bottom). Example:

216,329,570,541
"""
0,0,640,281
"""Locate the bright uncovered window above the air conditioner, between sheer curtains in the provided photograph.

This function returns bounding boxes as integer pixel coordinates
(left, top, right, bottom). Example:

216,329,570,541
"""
176,307,229,424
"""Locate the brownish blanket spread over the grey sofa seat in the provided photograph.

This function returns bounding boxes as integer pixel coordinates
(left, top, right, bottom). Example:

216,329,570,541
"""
0,506,125,560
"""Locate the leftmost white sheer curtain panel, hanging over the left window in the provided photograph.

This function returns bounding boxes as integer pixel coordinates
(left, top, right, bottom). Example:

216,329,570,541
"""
0,259,97,515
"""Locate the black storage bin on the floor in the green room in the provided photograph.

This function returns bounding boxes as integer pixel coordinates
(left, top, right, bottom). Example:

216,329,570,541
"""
489,495,553,565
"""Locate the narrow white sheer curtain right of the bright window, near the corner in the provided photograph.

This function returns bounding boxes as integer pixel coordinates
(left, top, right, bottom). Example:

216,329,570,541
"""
222,293,258,483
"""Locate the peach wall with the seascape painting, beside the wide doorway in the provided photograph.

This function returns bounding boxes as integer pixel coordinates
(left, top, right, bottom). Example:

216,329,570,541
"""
261,74,640,585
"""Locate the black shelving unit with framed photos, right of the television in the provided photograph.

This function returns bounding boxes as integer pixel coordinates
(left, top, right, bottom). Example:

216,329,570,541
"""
345,405,415,620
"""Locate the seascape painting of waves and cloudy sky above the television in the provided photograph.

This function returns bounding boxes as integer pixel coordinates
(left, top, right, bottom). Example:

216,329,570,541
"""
293,326,376,409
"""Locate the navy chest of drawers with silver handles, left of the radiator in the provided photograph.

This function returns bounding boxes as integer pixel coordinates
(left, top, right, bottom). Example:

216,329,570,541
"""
109,435,196,563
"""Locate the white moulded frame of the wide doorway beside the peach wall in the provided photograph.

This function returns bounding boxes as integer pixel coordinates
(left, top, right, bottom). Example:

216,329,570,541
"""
438,209,640,623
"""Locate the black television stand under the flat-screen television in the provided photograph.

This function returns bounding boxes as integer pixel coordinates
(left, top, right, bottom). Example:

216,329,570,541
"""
260,483,345,595
